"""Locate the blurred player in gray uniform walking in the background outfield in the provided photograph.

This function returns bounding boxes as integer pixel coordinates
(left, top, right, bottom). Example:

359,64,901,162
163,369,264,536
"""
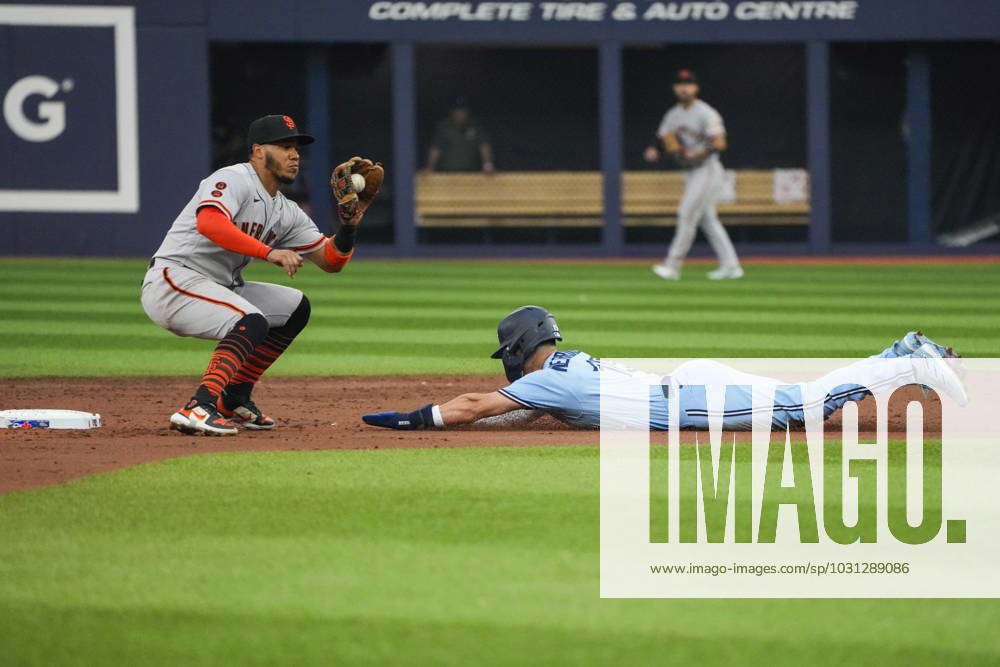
643,69,743,280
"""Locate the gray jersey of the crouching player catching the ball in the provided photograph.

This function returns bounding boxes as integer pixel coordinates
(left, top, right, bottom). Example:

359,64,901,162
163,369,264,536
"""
154,163,326,286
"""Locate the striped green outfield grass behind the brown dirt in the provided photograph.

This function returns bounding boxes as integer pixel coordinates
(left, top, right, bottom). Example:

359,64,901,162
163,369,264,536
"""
0,259,1000,377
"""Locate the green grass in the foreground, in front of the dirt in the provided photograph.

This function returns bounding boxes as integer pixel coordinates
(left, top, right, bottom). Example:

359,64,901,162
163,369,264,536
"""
0,444,1000,666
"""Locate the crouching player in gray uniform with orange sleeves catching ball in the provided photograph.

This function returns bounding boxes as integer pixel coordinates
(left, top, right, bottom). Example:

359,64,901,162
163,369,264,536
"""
141,115,384,435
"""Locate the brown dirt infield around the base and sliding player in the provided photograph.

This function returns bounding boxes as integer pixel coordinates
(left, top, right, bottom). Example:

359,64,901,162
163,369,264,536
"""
0,376,921,493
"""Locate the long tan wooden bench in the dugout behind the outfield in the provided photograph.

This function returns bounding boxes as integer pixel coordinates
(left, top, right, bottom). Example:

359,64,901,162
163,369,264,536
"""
416,171,809,227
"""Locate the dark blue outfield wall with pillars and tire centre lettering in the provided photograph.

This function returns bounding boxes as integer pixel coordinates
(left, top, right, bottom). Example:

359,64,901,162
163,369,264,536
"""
0,0,1000,256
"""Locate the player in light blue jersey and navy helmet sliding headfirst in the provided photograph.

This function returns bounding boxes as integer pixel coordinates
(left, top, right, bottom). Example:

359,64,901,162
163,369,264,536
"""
362,306,968,431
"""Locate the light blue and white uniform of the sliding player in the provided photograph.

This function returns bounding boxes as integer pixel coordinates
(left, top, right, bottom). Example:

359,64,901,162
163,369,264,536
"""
499,341,910,431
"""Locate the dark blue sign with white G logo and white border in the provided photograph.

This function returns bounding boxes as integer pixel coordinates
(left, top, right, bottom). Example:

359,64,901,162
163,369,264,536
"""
0,4,139,213
